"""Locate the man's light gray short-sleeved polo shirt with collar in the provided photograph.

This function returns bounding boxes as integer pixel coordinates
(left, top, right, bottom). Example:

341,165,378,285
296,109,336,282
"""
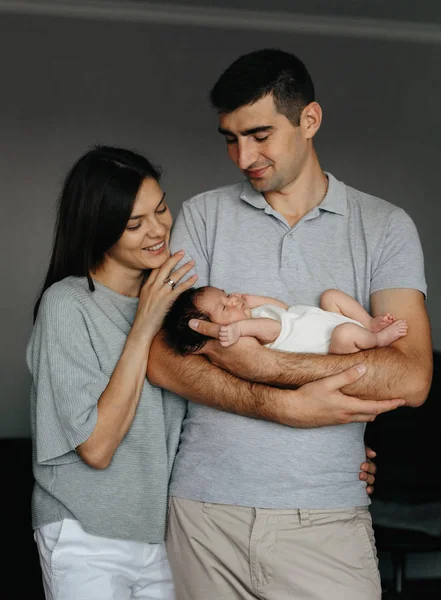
170,175,426,508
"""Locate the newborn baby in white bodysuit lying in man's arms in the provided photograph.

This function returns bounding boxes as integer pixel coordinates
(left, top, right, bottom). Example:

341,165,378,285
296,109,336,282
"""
163,286,407,355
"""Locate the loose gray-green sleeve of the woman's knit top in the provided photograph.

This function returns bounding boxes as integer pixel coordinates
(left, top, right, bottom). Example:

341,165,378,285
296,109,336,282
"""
27,289,109,464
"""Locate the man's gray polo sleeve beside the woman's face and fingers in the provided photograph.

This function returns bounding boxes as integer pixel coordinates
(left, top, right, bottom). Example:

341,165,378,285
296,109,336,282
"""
170,199,210,287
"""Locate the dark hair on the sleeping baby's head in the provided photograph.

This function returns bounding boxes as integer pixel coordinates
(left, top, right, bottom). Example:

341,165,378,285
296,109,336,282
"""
162,286,211,356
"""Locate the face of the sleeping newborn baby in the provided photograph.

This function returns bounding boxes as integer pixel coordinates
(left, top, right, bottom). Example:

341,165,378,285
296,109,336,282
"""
197,286,251,325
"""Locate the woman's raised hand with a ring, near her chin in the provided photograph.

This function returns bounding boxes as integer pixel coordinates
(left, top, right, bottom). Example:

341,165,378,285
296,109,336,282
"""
132,250,198,339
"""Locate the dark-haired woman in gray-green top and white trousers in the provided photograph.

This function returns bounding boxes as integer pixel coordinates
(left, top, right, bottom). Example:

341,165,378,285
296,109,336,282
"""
27,147,197,600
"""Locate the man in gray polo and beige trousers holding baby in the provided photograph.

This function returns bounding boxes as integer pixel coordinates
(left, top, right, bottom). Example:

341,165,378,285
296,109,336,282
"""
149,50,432,600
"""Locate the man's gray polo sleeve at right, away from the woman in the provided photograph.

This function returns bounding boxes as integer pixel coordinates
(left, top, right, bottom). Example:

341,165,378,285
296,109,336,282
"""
371,208,427,295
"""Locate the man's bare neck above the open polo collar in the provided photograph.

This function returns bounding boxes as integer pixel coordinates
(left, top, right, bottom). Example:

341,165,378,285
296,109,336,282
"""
264,157,328,227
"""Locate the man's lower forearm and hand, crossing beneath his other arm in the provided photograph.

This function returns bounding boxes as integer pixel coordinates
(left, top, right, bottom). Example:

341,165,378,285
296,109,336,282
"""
147,332,403,427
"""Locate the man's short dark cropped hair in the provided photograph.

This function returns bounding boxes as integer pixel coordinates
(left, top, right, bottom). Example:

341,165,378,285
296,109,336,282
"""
210,48,315,125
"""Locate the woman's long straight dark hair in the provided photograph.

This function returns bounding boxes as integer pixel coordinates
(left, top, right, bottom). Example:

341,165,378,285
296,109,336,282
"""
34,146,161,321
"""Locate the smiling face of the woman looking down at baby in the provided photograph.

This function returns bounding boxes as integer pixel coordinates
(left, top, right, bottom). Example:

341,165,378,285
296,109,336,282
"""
106,179,172,271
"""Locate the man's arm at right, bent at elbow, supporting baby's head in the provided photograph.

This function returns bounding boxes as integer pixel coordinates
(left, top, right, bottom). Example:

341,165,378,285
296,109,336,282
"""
193,289,432,406
